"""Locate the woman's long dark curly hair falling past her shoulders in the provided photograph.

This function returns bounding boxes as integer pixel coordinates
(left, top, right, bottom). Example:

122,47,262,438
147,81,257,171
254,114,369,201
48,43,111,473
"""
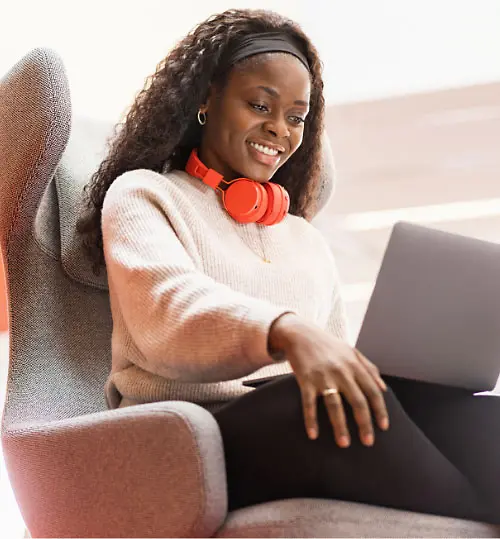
77,9,324,275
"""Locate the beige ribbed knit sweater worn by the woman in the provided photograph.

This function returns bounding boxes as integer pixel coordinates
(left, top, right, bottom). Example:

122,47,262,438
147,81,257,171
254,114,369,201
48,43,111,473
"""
102,170,346,408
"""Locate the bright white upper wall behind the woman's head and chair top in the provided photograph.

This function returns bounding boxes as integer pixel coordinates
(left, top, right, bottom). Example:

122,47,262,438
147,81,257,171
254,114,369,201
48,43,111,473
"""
0,0,500,119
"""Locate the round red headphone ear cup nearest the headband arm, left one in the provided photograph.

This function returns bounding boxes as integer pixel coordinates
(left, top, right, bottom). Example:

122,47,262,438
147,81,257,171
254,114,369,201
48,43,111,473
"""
222,179,269,223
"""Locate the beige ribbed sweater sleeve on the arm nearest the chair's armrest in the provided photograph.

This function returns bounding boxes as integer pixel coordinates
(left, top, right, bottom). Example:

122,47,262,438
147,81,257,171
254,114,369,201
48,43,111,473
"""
102,172,288,383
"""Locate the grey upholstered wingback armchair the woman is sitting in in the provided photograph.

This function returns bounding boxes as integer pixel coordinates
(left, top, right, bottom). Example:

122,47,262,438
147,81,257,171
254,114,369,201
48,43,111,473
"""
0,49,500,537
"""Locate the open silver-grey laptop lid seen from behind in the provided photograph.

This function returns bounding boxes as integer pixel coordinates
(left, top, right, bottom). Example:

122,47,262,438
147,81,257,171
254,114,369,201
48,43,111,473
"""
356,222,500,392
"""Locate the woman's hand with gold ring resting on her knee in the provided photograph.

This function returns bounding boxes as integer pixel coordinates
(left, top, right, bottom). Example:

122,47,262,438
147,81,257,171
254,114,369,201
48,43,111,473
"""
269,314,389,447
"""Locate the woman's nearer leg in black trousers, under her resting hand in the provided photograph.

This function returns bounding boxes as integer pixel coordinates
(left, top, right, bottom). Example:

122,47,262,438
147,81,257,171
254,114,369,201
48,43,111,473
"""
214,375,489,520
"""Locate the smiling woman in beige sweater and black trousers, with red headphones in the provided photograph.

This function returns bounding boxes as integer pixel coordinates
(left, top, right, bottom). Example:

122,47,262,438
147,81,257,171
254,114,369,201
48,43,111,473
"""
79,10,500,522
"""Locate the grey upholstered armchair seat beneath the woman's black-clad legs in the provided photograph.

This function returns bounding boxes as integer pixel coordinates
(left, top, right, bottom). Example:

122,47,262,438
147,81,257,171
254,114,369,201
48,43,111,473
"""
215,499,500,537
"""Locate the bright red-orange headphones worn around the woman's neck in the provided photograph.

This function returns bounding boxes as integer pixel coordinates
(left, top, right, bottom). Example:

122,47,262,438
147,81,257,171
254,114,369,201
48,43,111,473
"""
186,149,290,225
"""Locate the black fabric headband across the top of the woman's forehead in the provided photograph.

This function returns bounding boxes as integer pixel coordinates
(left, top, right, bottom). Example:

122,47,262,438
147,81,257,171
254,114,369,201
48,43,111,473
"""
225,32,310,71
